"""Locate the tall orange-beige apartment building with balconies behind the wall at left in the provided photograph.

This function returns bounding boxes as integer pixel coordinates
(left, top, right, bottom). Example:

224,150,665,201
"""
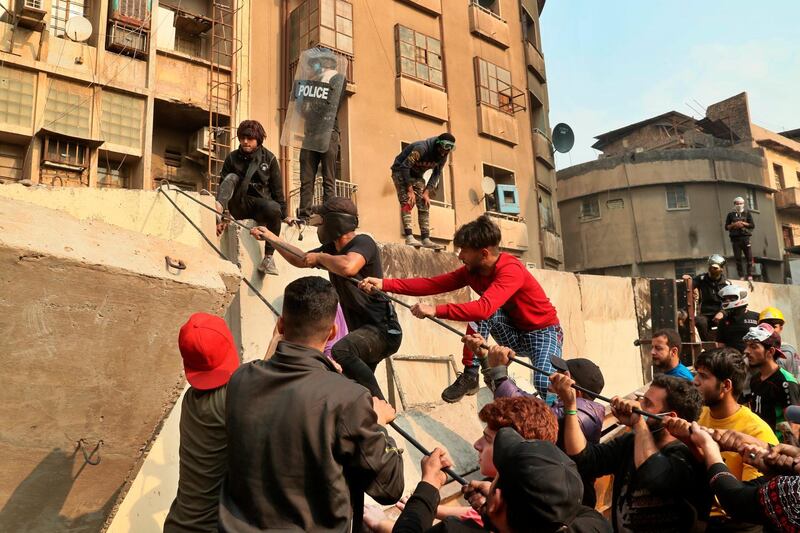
0,0,563,268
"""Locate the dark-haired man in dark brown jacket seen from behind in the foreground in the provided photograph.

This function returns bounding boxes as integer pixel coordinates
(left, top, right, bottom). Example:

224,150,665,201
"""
219,276,403,533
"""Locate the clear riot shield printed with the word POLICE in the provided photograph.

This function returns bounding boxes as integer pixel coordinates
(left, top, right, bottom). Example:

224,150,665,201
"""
281,48,347,152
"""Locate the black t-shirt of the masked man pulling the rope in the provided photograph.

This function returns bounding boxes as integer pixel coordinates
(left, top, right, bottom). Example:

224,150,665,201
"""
312,235,400,332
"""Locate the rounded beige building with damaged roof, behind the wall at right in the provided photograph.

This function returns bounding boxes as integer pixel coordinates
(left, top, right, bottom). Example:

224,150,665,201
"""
558,93,800,283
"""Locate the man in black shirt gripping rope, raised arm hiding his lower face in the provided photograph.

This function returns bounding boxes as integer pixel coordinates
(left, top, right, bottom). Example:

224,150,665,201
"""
550,374,711,533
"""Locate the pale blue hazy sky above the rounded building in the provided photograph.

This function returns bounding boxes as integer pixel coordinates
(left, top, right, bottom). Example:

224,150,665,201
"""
541,0,800,169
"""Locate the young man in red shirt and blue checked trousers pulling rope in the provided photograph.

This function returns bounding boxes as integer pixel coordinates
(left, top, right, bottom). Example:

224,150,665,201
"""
359,215,564,402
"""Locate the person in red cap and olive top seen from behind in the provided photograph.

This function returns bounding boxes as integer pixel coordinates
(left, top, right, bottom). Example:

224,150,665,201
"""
164,313,239,533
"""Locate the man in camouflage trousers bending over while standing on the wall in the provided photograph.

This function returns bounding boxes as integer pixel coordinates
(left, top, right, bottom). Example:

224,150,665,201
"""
392,132,456,248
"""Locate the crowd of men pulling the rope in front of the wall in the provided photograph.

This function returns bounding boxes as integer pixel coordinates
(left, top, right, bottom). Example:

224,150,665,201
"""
164,198,800,533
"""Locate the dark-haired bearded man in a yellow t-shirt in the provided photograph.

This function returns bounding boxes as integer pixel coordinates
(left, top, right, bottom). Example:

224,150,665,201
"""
694,348,778,533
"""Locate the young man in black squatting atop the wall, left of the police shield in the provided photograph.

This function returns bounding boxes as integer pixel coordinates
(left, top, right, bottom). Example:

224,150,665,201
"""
217,120,287,275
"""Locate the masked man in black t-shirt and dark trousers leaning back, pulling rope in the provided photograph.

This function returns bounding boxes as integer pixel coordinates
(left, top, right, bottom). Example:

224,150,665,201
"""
251,196,403,399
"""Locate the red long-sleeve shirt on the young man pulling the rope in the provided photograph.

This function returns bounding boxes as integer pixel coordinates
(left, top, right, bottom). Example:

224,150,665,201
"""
383,253,558,331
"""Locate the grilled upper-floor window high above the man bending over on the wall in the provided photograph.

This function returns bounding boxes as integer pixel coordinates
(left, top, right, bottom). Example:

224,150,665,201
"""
395,24,444,89
